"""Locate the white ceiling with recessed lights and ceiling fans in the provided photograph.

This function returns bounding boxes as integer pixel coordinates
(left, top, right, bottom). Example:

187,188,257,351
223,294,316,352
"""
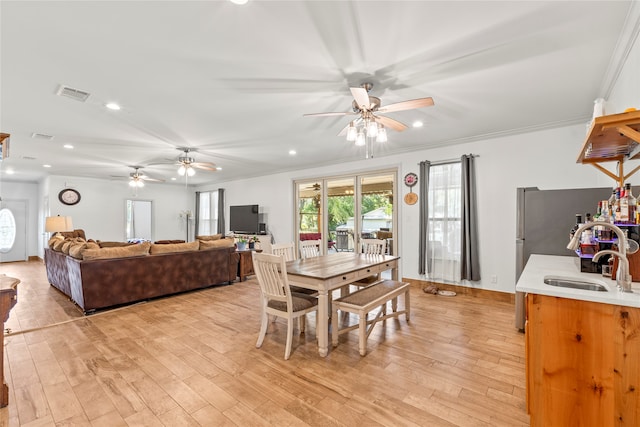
0,0,632,185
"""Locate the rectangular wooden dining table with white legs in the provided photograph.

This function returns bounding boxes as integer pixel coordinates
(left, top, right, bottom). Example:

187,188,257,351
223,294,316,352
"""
287,252,400,357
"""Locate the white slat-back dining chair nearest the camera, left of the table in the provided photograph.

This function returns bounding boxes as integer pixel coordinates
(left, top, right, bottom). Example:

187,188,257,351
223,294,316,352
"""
251,252,318,360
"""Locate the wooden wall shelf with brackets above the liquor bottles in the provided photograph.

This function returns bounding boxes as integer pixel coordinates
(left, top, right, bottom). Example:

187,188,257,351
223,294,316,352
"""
577,111,640,187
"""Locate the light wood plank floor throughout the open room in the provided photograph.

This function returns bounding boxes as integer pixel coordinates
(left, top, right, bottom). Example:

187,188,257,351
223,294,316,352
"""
0,262,529,427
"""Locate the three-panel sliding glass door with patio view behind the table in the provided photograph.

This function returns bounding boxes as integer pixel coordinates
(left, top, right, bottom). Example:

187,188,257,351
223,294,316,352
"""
294,169,398,254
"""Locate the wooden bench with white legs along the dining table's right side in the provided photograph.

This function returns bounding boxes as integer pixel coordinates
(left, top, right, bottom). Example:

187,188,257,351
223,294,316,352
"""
331,280,411,356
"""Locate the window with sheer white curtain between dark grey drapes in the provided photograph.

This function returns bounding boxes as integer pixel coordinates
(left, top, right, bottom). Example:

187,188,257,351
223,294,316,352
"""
427,162,462,283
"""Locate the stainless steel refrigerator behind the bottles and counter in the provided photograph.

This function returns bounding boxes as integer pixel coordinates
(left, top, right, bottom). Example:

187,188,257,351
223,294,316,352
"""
516,187,611,331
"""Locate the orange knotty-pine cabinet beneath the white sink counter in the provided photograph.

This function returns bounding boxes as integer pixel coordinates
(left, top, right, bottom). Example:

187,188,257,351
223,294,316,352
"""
525,294,640,427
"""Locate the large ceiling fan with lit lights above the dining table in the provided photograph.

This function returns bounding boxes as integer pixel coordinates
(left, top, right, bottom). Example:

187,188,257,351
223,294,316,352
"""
305,83,433,145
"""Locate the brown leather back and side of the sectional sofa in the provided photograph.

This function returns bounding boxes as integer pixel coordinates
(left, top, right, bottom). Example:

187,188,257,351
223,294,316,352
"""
44,248,239,314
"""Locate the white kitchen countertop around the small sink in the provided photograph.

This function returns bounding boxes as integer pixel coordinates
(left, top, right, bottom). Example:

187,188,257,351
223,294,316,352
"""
516,255,640,307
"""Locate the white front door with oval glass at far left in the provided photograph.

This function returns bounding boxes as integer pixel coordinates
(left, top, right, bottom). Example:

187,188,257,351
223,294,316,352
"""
0,200,27,262
